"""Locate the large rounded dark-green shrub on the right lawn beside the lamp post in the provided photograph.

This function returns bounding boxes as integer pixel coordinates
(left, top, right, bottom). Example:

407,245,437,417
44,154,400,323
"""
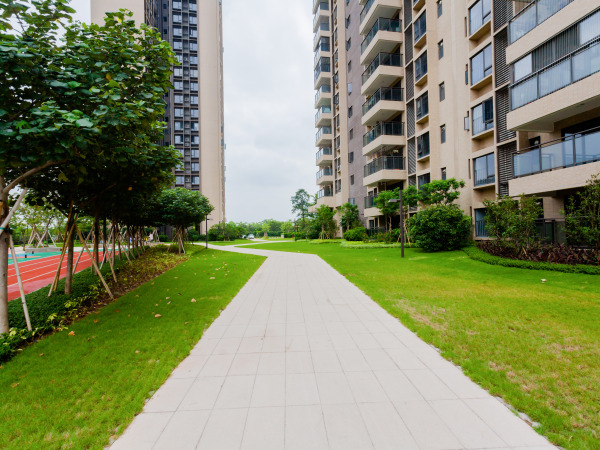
410,205,471,252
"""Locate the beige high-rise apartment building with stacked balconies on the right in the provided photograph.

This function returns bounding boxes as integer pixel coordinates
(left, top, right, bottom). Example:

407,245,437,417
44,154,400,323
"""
313,0,600,237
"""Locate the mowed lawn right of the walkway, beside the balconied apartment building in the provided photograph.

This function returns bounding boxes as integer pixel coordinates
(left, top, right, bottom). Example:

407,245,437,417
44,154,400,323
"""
246,242,600,449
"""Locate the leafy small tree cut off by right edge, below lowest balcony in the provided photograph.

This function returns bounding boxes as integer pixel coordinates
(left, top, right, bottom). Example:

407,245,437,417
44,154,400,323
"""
565,175,600,250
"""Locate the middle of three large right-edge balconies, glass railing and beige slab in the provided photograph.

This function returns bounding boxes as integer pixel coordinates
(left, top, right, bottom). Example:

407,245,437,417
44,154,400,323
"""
507,37,600,131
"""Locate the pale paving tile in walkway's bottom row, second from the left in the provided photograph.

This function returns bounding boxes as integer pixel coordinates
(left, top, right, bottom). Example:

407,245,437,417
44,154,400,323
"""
152,411,210,450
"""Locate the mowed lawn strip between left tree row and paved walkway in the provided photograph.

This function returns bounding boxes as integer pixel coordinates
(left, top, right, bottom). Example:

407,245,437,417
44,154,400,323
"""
0,247,264,449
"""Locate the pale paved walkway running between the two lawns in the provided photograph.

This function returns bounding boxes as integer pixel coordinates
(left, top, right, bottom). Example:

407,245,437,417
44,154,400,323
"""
112,247,553,450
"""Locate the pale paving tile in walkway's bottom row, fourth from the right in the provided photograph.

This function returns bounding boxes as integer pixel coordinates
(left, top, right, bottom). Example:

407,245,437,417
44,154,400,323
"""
358,402,419,450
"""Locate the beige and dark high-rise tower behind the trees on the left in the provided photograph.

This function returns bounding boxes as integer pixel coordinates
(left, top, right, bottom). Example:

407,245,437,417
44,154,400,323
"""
91,0,225,231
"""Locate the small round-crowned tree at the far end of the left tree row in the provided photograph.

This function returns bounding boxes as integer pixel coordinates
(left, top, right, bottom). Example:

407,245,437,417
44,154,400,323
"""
156,188,214,253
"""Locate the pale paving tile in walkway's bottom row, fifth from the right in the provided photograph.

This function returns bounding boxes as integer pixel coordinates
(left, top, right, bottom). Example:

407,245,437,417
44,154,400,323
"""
322,405,373,450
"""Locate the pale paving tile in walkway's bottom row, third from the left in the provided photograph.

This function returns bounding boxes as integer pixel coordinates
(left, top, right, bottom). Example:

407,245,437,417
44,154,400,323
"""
196,408,248,450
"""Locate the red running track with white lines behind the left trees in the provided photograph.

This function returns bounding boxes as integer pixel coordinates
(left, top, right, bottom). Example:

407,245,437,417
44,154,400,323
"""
8,252,109,301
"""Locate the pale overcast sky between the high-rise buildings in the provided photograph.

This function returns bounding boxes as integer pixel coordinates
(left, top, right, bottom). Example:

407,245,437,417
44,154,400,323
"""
71,0,317,222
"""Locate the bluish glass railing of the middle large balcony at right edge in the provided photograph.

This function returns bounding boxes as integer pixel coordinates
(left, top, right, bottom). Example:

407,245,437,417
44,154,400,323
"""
510,38,600,110
